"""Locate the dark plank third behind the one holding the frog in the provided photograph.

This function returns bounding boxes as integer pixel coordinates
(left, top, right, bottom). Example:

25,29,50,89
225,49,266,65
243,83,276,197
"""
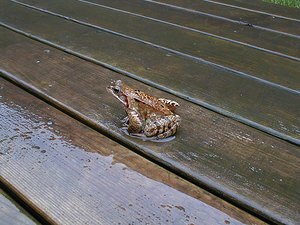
78,0,300,57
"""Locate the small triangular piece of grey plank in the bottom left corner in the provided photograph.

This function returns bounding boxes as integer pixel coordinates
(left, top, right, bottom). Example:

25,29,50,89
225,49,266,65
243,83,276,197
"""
0,189,40,225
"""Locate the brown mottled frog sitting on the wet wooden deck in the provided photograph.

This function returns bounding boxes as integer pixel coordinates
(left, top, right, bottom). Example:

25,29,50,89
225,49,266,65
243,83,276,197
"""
107,80,181,139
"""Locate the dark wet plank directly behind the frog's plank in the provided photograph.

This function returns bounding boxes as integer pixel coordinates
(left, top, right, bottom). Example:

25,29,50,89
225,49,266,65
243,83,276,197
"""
0,0,300,143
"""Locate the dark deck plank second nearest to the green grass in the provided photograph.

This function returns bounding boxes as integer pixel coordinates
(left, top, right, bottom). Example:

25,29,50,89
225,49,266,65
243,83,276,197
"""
153,0,300,37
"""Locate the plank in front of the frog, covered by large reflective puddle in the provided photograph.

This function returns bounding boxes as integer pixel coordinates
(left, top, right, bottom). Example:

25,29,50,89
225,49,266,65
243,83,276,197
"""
0,78,264,225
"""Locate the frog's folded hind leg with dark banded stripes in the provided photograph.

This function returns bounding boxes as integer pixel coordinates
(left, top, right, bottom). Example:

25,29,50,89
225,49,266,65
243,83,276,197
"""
144,115,181,139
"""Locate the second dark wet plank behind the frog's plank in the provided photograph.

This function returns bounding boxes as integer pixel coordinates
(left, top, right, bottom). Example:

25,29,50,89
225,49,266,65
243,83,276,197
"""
11,0,300,86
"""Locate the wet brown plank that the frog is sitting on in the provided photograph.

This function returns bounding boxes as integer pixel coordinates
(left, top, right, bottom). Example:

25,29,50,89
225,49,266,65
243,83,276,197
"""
0,29,300,224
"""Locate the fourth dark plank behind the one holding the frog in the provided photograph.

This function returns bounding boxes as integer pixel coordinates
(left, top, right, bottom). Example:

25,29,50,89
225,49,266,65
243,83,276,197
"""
152,0,300,36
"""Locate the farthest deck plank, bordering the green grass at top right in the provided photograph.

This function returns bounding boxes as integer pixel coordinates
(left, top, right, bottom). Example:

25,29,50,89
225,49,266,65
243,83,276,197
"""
209,0,300,20
